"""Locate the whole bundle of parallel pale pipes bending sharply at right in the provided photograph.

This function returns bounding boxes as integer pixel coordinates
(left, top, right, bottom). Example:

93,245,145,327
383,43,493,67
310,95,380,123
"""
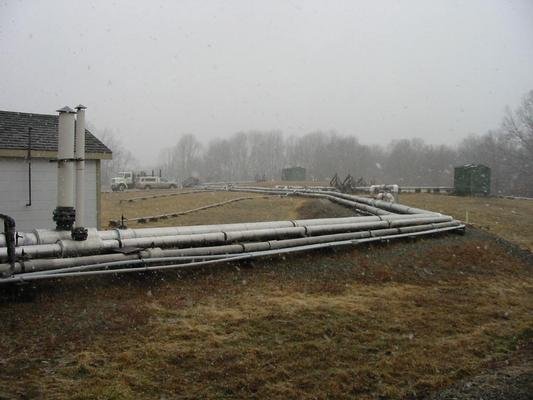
0,186,464,283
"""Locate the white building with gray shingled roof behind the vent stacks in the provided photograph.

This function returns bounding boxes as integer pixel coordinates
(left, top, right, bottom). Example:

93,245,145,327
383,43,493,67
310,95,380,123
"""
0,111,111,232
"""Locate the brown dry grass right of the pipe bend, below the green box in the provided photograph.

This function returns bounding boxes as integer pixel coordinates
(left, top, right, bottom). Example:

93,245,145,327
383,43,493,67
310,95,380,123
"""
400,193,533,251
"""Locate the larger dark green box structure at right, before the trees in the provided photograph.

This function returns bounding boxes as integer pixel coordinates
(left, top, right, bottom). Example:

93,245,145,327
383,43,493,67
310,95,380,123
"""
453,164,490,196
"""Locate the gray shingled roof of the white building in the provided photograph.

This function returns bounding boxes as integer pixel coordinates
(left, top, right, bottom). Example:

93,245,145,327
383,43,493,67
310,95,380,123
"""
0,110,111,153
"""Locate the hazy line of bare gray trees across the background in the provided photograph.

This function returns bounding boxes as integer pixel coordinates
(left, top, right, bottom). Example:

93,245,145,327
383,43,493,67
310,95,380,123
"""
101,91,533,197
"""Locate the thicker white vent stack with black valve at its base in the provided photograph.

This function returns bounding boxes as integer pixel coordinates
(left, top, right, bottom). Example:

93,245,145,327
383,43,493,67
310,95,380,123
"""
53,106,76,230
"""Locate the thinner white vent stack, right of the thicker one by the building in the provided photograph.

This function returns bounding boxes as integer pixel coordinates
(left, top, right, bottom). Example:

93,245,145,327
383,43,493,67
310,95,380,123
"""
74,104,87,228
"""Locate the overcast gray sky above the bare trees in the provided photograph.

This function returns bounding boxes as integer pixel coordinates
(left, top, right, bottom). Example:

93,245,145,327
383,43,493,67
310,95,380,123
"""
0,0,533,162
